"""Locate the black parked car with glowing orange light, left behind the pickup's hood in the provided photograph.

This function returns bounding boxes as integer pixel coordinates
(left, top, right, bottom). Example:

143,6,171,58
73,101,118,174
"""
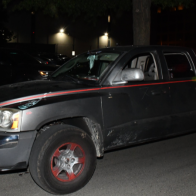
0,48,58,85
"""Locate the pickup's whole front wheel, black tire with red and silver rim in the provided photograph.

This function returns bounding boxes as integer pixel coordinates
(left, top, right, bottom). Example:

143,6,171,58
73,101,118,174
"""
29,125,96,194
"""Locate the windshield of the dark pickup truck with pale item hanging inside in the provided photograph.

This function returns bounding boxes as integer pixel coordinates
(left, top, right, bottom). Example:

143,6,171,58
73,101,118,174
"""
51,51,120,81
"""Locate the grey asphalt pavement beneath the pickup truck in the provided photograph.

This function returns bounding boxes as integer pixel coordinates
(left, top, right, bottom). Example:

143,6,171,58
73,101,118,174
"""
0,134,196,196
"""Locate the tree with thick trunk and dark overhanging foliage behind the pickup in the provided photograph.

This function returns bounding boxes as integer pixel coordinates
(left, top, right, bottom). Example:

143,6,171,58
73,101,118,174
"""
2,0,193,45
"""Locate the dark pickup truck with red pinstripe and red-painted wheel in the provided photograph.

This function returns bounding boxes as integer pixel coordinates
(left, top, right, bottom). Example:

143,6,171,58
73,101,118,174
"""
0,46,196,194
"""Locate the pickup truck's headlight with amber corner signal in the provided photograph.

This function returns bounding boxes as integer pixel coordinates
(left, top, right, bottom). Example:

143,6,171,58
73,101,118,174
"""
0,108,21,132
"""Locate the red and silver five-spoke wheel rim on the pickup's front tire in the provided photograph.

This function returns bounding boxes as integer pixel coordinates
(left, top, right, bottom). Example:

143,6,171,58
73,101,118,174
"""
51,142,86,182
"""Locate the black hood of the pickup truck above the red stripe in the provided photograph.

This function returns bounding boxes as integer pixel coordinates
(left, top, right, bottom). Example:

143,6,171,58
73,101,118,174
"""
0,80,98,107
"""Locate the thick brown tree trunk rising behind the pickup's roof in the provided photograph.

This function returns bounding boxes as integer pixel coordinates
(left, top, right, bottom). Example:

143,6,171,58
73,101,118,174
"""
133,0,151,45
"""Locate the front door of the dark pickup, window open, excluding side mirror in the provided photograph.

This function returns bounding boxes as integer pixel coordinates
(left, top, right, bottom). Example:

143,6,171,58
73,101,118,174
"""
102,50,171,148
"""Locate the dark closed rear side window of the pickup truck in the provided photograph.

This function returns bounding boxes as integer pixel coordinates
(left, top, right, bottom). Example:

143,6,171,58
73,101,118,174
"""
164,53,195,79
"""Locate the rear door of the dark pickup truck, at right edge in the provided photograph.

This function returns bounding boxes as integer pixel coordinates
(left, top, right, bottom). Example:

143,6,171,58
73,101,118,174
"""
163,50,196,135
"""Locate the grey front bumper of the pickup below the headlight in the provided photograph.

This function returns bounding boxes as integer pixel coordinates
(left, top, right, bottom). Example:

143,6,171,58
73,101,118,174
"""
0,131,36,171
